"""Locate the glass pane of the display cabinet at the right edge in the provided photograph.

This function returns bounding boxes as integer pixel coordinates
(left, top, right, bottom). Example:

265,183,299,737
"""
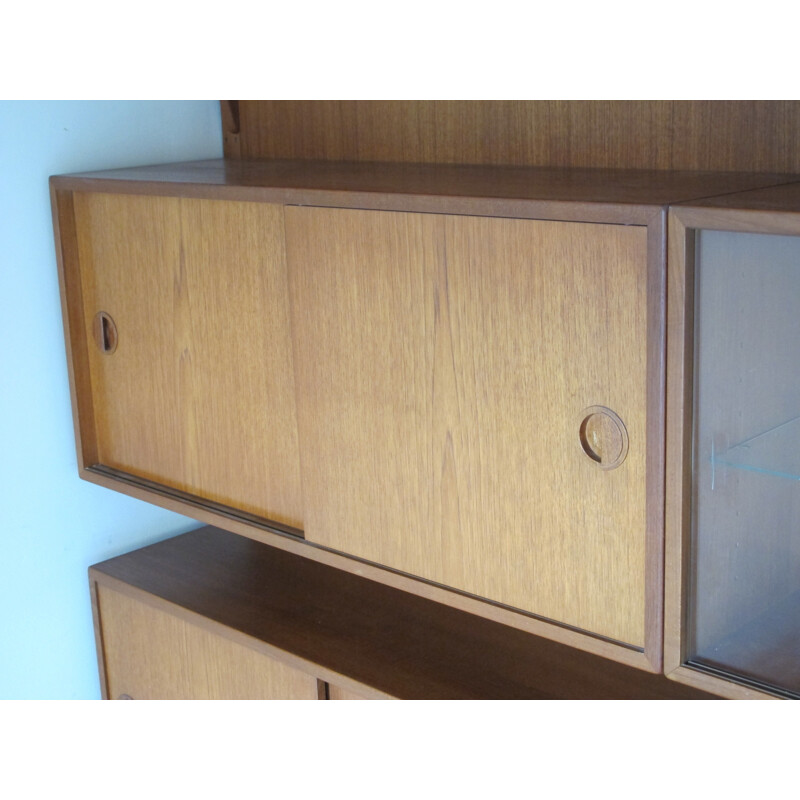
689,231,800,695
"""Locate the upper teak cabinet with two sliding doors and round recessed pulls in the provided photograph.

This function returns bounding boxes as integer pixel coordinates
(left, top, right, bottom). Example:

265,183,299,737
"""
52,161,797,696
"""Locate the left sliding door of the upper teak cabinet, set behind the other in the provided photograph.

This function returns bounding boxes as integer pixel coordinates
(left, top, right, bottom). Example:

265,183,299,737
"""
74,193,302,527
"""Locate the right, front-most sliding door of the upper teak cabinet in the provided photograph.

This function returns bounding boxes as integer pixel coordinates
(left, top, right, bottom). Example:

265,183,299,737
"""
286,207,647,647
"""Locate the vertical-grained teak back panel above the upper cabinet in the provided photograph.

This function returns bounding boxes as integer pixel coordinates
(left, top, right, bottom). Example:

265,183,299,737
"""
230,100,800,172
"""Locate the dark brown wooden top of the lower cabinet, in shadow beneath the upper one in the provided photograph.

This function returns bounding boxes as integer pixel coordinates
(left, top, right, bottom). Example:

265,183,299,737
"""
90,528,713,699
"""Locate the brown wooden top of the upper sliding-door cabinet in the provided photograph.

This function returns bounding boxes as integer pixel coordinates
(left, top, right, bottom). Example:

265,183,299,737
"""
53,159,800,222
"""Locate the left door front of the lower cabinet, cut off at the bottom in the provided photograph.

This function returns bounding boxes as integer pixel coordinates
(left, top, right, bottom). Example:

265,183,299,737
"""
97,586,318,700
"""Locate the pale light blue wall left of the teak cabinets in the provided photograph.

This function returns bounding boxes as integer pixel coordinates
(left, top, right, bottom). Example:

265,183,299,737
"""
0,101,222,699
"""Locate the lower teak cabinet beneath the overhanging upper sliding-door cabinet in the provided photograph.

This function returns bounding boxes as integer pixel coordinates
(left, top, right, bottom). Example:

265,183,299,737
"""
89,527,714,700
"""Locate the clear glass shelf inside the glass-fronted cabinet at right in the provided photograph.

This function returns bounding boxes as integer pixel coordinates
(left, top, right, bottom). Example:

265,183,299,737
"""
711,417,800,481
